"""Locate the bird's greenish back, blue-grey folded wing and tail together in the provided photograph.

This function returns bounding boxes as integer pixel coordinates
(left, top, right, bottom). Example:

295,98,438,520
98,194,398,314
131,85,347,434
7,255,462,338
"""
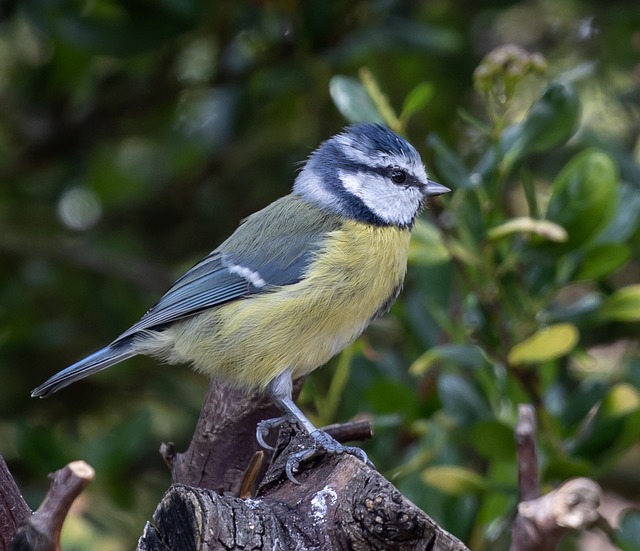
32,194,341,396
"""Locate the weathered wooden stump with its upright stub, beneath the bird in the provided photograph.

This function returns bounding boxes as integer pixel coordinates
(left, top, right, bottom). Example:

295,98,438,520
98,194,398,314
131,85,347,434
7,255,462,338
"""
138,382,466,551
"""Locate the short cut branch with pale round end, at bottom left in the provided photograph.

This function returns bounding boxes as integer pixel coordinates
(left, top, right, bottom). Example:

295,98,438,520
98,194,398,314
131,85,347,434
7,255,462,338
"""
10,461,95,551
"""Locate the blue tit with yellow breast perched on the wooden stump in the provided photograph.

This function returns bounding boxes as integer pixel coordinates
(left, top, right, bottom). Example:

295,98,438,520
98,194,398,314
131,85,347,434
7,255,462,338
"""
31,123,450,482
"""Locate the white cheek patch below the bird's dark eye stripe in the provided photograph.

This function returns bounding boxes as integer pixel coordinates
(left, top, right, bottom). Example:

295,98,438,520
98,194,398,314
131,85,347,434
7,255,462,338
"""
339,171,422,225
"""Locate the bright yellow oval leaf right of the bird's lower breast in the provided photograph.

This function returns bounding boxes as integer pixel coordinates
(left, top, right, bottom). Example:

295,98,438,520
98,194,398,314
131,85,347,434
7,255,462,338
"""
508,323,580,365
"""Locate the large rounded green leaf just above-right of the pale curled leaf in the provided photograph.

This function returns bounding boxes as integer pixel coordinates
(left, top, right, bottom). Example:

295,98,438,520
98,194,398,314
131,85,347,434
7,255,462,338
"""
546,149,619,250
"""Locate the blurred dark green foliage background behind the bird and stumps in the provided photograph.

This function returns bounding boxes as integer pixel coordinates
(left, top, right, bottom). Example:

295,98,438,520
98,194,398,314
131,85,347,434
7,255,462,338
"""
0,0,640,551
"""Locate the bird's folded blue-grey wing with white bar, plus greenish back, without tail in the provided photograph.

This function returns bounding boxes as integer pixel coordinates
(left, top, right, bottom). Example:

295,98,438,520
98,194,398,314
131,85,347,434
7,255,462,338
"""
115,196,336,342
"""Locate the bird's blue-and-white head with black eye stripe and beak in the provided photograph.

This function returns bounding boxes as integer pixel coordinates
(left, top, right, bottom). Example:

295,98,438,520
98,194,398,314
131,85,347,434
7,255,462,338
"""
293,123,450,227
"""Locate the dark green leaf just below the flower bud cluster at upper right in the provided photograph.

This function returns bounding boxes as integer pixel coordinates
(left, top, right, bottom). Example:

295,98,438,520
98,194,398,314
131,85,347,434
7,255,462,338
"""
503,82,580,170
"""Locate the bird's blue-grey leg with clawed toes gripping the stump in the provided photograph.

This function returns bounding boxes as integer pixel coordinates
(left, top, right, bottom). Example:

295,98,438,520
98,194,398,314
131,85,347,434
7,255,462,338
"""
256,370,373,484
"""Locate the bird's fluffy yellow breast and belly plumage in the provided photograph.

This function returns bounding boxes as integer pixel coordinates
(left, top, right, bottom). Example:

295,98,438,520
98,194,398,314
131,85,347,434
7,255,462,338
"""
159,220,410,389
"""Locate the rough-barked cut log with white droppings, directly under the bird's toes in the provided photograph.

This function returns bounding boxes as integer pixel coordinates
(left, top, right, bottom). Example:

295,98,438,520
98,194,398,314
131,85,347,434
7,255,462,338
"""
137,433,467,551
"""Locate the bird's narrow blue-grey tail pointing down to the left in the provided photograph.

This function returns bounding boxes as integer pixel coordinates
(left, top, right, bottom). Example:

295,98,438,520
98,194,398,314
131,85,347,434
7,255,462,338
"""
31,343,135,398
